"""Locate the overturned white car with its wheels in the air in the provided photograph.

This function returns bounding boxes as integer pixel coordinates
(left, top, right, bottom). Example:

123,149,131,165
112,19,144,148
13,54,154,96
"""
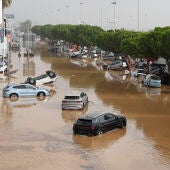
24,71,58,85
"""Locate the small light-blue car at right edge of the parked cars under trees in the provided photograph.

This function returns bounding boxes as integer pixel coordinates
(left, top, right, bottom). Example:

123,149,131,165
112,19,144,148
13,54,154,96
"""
143,74,161,88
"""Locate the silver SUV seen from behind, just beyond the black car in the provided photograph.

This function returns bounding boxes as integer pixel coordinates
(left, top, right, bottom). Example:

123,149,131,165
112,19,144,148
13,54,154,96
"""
62,91,88,110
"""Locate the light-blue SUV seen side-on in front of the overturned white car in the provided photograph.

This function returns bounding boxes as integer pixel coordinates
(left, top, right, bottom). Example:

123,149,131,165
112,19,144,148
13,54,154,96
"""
3,84,50,100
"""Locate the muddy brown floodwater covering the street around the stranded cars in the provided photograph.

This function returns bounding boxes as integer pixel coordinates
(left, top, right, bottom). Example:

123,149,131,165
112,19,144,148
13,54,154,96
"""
0,49,170,170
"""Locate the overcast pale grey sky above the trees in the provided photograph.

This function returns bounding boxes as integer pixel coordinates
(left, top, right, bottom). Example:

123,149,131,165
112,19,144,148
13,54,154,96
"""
5,0,170,31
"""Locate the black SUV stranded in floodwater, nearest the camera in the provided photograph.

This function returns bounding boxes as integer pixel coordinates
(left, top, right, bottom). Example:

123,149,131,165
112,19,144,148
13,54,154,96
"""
73,113,126,136
